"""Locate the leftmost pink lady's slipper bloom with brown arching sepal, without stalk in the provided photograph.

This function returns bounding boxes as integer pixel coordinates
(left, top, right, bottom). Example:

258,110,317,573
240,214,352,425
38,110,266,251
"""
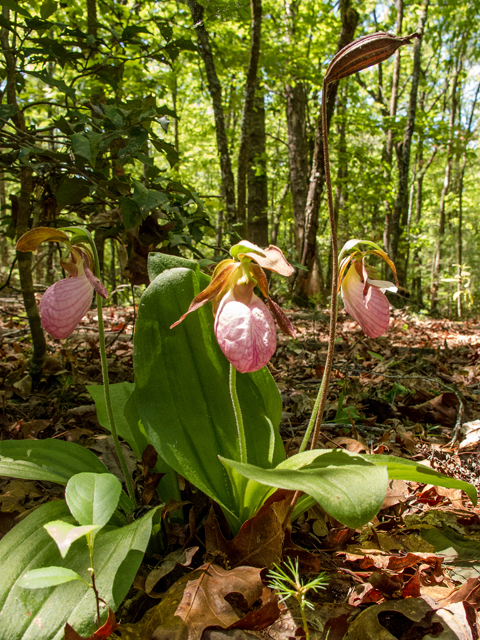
17,227,108,339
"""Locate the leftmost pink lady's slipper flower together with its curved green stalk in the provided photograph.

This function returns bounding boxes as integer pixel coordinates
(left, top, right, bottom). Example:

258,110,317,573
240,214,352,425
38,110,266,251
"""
16,227,135,505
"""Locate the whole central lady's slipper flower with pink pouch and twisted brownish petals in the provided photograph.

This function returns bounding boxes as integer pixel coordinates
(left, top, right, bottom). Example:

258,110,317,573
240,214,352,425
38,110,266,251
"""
171,240,295,373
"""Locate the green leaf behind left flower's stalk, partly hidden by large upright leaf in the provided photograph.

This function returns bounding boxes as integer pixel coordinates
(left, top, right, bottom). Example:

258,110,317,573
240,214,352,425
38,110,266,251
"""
87,382,180,502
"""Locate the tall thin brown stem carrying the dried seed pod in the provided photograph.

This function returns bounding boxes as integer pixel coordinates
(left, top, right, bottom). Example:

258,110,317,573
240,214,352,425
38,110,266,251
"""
283,78,338,527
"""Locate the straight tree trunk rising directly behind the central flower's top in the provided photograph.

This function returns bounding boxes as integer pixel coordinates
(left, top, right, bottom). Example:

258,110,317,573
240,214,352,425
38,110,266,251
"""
247,84,268,247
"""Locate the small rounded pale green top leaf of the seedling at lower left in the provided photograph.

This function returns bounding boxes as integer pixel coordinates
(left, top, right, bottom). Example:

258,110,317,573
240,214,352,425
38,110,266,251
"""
65,473,122,527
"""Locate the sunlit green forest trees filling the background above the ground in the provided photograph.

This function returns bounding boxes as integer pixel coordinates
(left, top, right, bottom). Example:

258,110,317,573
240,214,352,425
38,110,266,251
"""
0,0,480,316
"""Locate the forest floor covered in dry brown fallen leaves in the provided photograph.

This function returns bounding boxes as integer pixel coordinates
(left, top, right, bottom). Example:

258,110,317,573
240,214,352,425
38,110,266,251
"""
0,298,480,640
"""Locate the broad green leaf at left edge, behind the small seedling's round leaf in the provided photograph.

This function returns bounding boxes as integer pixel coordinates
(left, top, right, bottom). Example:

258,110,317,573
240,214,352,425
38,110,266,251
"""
0,438,132,511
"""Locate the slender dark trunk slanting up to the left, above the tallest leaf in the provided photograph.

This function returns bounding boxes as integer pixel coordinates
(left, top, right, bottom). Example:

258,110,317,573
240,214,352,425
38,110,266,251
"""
187,0,237,227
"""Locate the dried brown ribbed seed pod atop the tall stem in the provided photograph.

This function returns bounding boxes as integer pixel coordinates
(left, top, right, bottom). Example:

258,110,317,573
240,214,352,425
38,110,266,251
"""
324,31,421,83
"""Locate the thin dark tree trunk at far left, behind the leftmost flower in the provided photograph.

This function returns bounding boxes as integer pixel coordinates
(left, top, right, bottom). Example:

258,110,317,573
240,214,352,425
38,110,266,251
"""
0,7,47,386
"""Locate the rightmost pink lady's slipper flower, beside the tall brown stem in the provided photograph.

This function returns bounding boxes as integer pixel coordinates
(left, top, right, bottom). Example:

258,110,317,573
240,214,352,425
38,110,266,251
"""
339,249,398,338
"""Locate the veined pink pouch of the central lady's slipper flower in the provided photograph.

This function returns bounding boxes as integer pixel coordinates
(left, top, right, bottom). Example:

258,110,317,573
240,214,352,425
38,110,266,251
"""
215,285,277,373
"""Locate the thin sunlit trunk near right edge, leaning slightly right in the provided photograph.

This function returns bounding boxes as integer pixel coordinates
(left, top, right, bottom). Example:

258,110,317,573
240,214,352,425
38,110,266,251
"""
430,44,463,312
